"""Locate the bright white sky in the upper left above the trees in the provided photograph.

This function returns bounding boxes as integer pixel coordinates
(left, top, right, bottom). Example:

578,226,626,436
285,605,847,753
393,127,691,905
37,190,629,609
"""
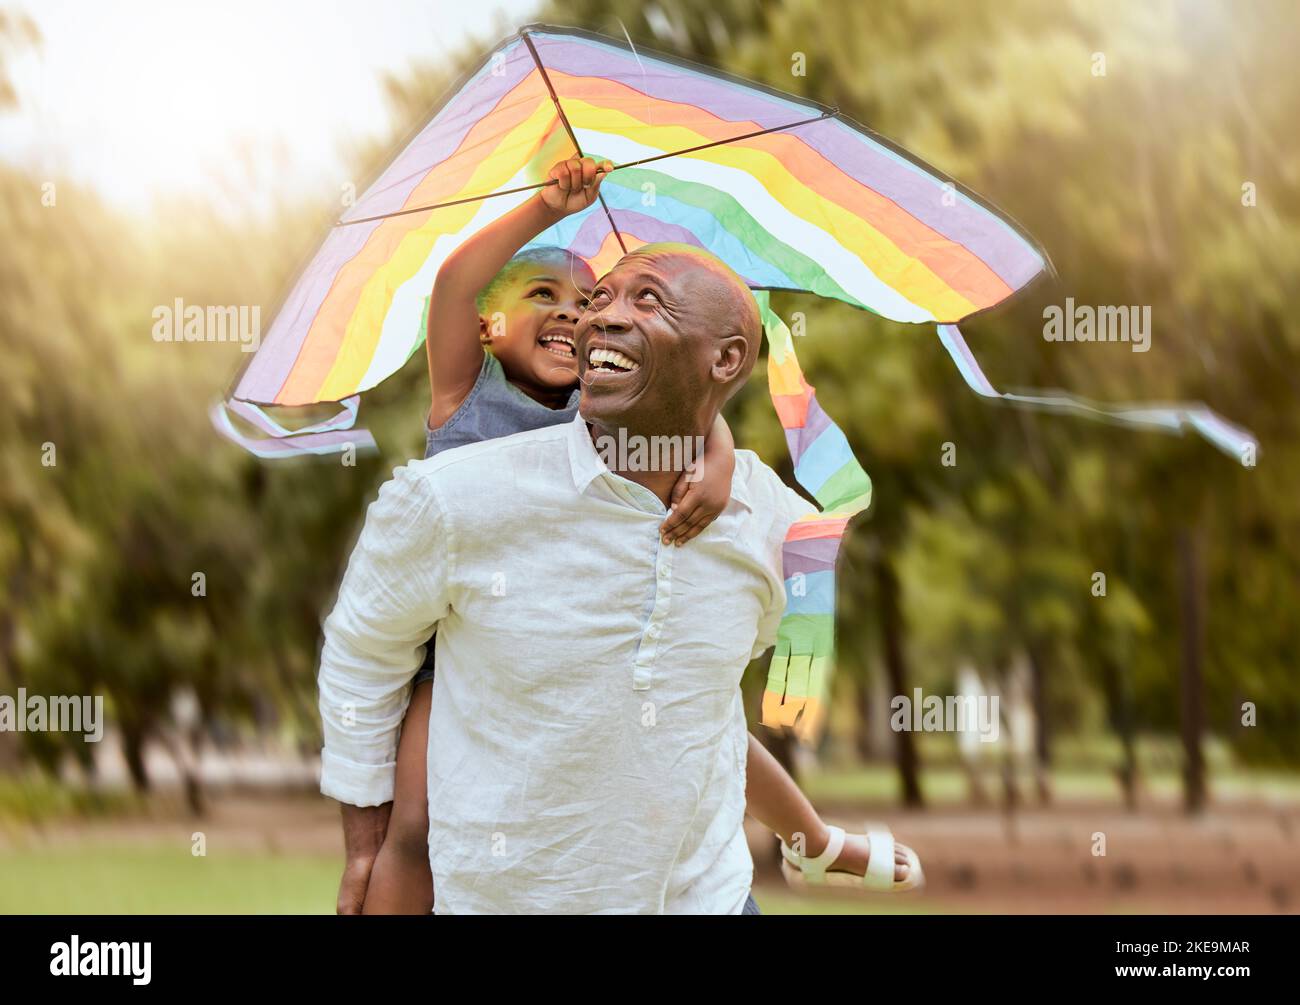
0,0,536,209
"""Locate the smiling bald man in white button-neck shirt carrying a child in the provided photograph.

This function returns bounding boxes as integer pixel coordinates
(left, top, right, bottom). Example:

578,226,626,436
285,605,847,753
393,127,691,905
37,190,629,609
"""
320,244,813,914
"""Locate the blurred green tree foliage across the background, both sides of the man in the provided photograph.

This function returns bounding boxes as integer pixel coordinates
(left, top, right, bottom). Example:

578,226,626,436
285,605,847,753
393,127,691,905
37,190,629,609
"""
0,0,1300,790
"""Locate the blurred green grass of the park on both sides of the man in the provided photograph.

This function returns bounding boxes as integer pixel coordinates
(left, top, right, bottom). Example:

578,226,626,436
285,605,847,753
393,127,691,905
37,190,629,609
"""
0,764,1300,915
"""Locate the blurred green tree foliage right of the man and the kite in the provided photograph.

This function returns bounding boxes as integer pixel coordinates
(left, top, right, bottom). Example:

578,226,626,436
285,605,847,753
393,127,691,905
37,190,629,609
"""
543,0,1300,764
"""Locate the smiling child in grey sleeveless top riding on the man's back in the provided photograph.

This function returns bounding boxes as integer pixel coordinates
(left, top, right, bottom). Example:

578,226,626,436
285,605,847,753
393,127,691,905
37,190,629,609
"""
364,157,919,914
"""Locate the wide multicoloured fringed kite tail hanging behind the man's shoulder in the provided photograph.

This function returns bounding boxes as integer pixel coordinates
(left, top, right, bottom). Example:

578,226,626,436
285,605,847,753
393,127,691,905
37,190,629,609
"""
754,290,871,744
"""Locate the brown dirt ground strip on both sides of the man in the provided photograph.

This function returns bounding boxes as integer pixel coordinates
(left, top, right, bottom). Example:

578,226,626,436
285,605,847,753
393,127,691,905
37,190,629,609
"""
0,793,1300,914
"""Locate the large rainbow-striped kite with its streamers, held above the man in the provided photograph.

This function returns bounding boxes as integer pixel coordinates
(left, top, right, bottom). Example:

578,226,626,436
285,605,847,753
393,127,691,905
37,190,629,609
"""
213,25,1251,738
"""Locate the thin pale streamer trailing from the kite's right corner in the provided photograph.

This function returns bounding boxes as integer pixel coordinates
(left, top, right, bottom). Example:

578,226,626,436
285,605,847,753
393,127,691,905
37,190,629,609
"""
939,325,1260,467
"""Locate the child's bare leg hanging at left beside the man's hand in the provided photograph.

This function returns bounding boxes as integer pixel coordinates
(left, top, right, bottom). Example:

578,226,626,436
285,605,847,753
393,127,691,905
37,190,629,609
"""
361,681,433,914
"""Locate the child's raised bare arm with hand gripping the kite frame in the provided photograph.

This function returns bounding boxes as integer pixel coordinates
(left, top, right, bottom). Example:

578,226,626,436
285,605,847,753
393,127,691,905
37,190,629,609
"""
425,157,614,428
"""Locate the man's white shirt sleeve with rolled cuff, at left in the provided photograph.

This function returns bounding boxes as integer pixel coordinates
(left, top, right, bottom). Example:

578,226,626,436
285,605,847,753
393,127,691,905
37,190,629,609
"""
317,463,452,806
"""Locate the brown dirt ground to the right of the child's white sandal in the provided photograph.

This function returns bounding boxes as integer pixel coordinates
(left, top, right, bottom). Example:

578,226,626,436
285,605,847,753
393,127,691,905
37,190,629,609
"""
751,805,1300,914
